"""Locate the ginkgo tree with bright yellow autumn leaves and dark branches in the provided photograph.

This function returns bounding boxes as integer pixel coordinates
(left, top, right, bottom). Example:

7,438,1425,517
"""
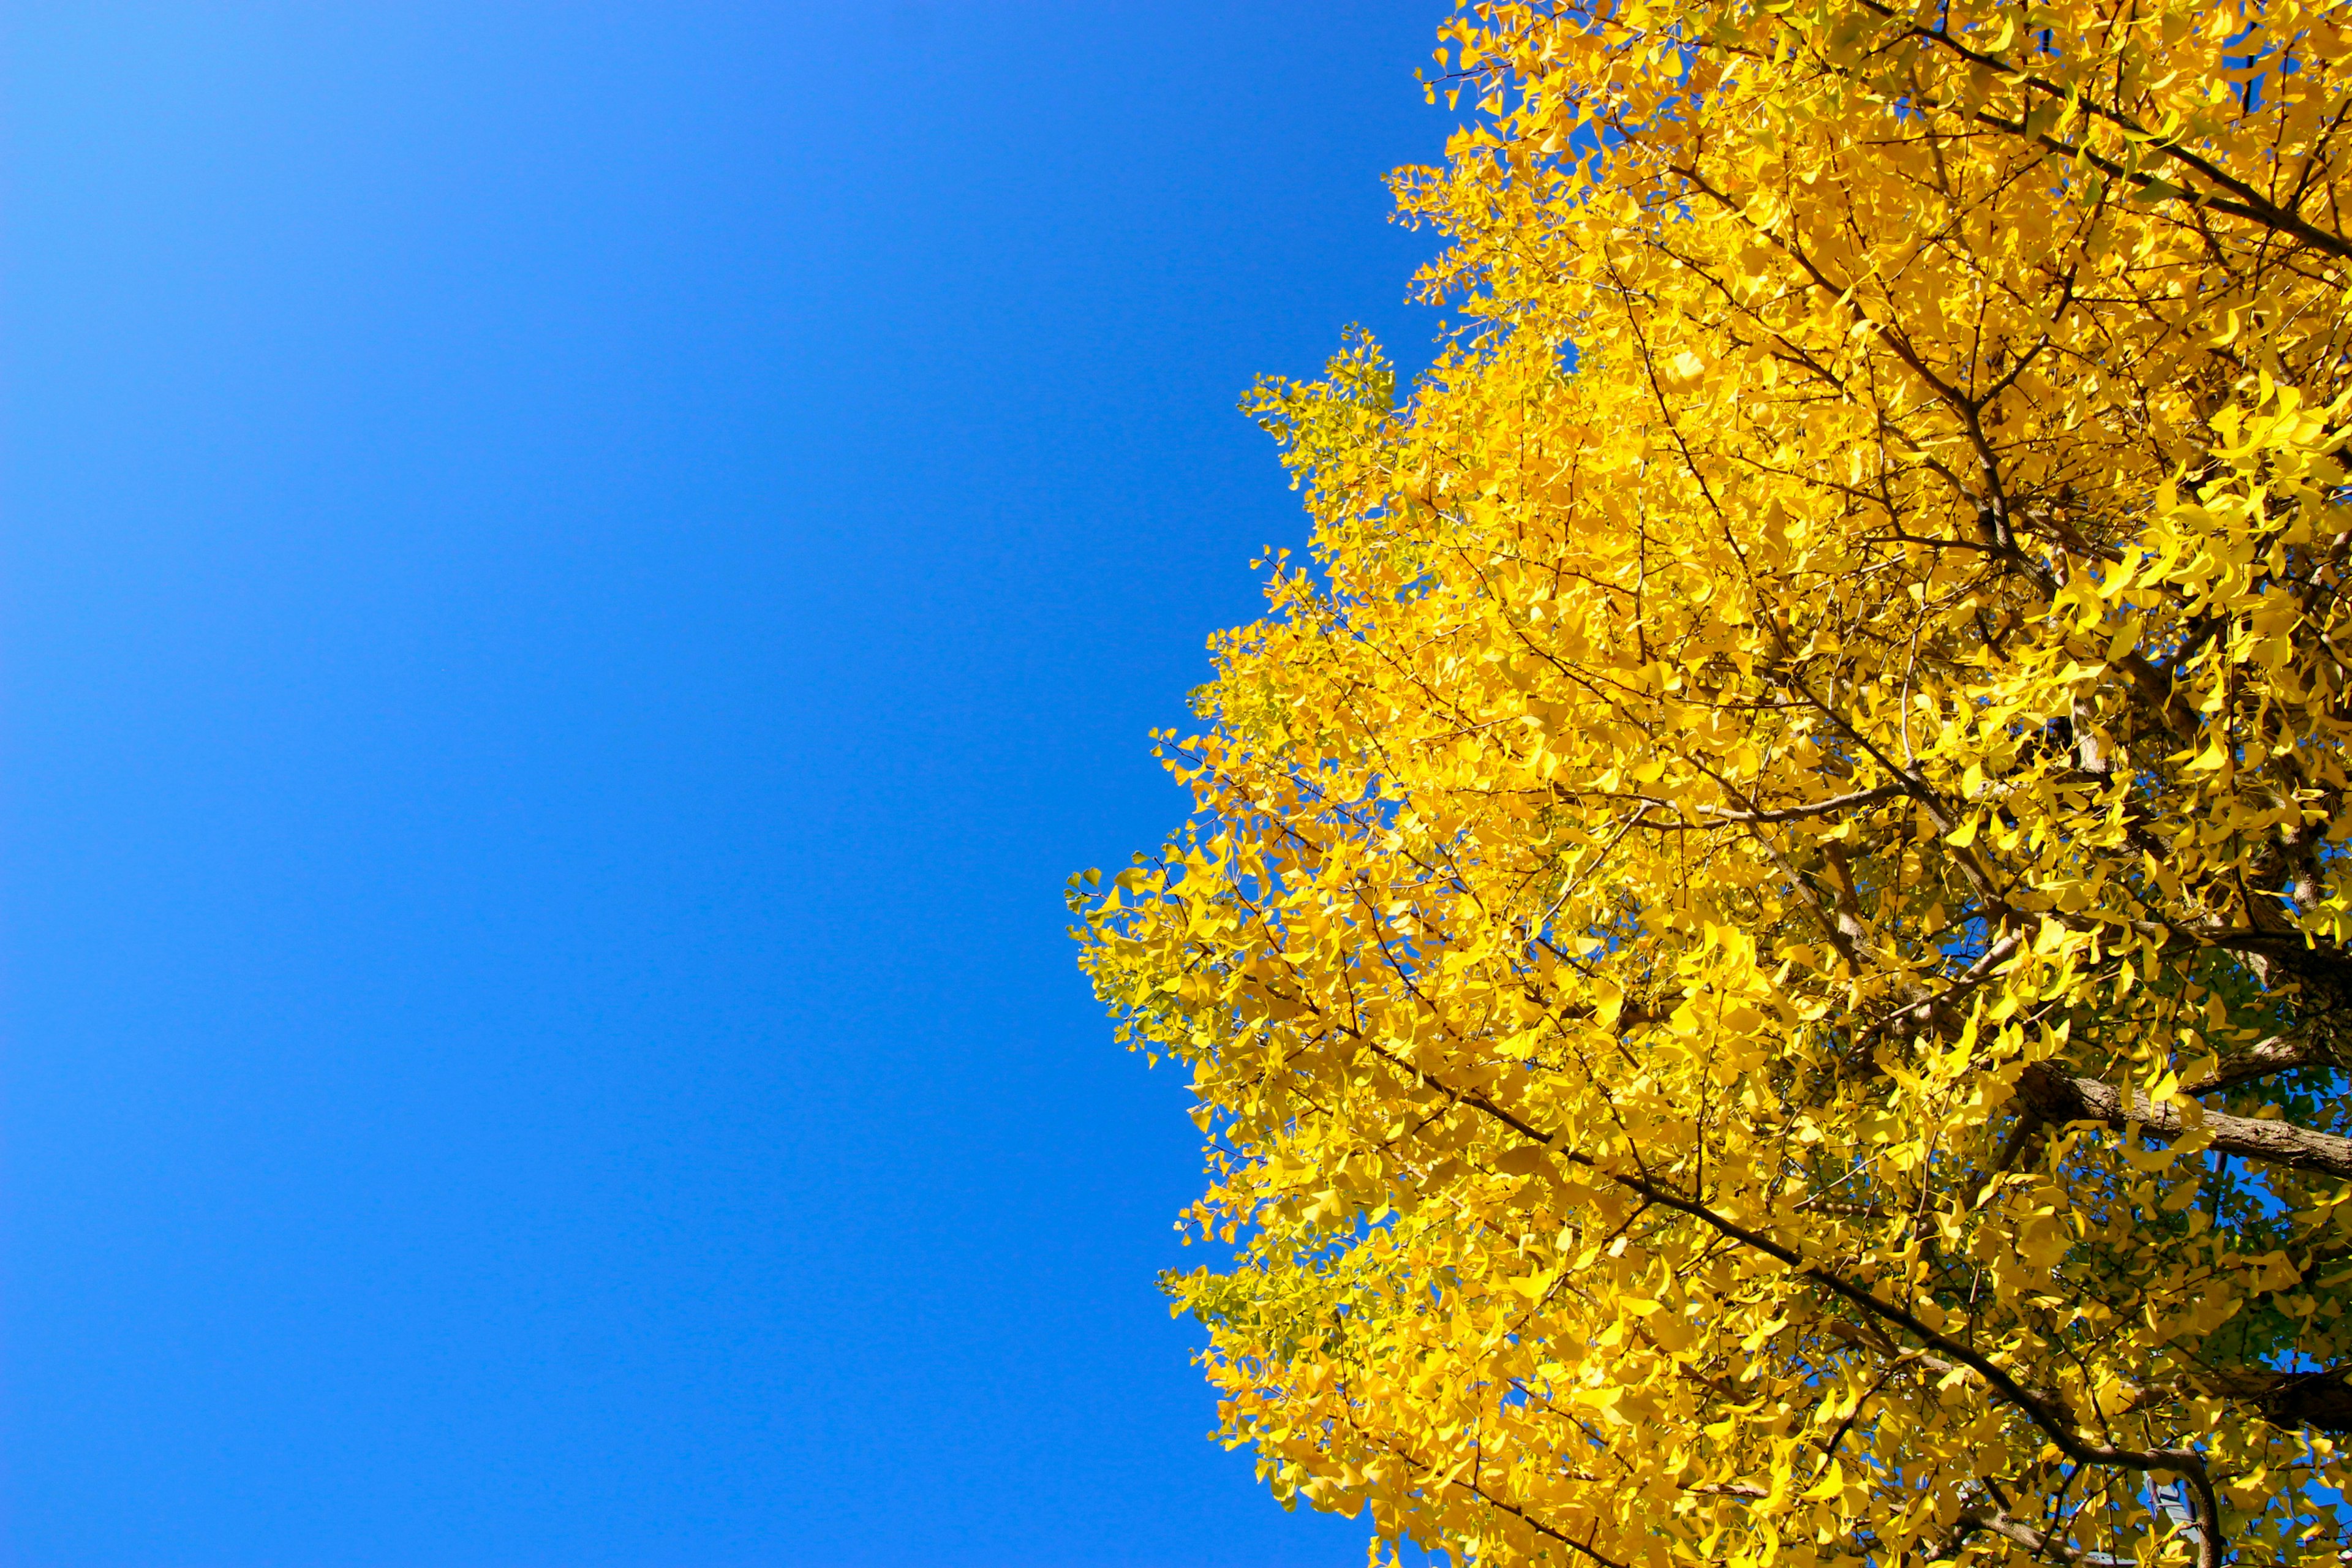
1072,0,2352,1568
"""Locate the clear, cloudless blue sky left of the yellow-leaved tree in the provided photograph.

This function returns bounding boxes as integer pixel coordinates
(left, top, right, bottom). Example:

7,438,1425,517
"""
0,0,1451,1568
